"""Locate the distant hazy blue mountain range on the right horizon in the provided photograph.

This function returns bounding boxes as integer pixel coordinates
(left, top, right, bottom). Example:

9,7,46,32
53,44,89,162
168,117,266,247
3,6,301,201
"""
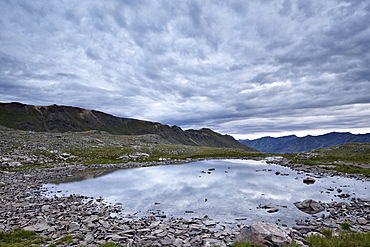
239,132,370,153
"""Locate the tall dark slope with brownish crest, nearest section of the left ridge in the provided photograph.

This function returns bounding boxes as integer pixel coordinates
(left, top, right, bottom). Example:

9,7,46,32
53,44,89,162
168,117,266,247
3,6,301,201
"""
0,103,160,135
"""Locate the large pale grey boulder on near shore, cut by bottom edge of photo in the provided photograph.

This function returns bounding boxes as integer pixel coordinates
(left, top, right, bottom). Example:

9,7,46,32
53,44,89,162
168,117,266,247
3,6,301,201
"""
236,222,293,246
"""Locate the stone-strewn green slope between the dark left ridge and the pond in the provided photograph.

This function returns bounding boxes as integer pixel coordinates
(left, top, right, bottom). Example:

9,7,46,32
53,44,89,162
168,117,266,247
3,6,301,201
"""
0,127,261,171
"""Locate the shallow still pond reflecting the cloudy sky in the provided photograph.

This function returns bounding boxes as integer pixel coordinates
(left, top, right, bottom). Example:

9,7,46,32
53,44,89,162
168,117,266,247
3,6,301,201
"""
44,159,370,226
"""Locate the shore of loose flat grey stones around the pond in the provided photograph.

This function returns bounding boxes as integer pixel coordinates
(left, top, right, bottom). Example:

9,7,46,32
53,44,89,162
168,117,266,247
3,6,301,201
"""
0,158,370,246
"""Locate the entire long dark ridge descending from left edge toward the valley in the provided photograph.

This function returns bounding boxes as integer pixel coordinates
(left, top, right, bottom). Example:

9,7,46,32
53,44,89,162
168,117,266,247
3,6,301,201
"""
0,102,257,152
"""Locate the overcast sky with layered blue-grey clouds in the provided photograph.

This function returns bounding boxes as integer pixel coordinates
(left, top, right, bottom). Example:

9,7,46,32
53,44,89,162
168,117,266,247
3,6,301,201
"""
0,0,370,139
